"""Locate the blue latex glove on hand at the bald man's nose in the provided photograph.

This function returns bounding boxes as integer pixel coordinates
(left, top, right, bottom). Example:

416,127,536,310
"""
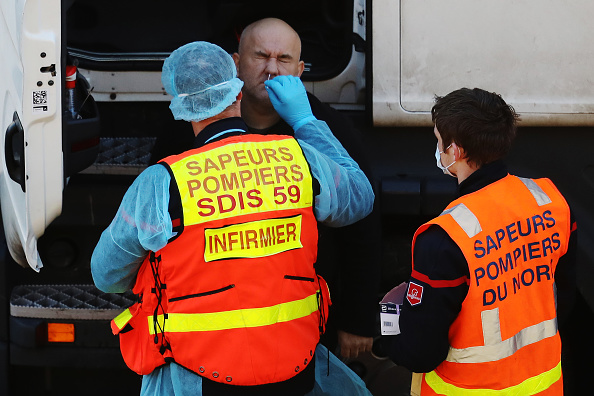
264,76,316,131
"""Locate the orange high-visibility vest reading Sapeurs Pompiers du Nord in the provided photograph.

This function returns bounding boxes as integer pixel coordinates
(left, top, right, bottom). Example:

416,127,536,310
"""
412,175,571,396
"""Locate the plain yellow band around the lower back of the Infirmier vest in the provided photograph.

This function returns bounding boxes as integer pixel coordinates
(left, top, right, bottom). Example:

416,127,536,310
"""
147,293,318,334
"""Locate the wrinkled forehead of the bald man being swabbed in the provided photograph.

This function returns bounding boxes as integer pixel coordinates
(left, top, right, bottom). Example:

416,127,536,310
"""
245,27,301,59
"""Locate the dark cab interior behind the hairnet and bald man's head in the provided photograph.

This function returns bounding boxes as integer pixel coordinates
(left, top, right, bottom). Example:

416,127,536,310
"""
65,0,353,81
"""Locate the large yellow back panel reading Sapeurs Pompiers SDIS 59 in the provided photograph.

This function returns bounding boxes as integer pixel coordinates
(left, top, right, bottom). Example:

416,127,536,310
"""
171,139,313,226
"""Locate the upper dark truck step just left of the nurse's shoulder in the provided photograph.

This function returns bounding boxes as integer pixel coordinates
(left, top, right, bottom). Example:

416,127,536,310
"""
80,137,156,175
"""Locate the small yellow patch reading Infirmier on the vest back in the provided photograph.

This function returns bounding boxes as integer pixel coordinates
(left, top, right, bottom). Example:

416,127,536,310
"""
204,215,303,262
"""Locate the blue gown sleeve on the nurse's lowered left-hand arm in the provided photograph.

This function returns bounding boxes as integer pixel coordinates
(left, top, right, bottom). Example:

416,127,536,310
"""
91,165,173,293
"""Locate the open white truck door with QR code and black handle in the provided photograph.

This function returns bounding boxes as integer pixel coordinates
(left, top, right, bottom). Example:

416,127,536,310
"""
0,0,64,271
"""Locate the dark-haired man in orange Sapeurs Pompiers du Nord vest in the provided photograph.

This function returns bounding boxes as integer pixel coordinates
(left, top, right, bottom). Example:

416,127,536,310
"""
383,88,576,396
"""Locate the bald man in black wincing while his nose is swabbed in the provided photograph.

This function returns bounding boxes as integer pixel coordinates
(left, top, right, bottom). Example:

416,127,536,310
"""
233,18,380,358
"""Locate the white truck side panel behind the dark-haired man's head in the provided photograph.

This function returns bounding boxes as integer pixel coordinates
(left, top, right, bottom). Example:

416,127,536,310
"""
371,0,594,126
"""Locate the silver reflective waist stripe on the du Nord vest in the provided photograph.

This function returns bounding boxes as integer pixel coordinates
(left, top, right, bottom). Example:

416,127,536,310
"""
446,308,557,363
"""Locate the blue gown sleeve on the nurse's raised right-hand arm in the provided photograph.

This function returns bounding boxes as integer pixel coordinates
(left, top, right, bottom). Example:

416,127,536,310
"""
295,120,375,227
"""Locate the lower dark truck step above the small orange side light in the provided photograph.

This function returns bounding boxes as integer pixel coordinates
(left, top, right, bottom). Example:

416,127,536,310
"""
10,285,136,320
